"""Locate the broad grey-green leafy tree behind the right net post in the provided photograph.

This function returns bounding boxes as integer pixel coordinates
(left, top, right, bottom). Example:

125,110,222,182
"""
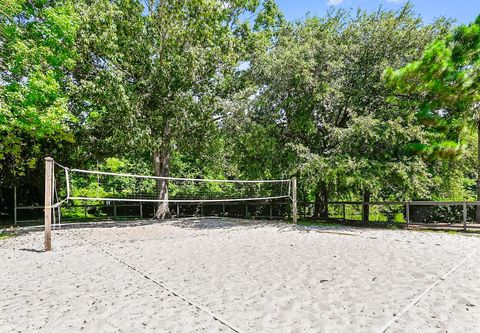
246,4,448,217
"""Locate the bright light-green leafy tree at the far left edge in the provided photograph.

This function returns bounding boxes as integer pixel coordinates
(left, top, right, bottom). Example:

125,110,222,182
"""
0,0,77,180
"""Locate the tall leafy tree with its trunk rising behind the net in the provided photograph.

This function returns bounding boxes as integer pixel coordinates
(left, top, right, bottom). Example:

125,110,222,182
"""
71,0,279,218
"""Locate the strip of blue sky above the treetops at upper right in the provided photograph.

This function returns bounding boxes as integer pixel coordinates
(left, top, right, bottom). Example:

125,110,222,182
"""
277,0,480,24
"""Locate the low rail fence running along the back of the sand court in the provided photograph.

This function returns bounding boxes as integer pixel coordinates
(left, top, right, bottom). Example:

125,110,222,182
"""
10,187,480,230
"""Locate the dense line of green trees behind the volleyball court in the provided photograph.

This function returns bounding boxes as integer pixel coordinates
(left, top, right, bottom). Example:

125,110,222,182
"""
0,0,480,218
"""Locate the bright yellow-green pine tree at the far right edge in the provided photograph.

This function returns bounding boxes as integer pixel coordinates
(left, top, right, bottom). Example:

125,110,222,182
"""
385,16,480,221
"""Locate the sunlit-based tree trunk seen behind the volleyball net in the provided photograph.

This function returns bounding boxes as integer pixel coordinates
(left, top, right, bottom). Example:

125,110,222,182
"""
153,123,172,219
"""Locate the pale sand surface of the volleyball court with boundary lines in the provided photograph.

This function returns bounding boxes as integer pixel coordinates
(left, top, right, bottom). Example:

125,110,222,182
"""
0,219,480,332
